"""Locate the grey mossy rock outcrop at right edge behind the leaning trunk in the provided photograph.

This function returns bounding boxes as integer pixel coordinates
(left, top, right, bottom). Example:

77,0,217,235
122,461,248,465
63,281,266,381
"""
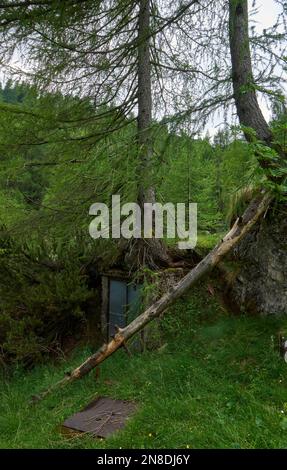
229,207,287,315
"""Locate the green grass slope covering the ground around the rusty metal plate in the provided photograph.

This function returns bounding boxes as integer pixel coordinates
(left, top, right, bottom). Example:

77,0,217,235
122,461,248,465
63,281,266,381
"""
0,285,287,448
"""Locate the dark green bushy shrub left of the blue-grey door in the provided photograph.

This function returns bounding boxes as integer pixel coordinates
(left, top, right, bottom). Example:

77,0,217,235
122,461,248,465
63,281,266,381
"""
0,231,92,365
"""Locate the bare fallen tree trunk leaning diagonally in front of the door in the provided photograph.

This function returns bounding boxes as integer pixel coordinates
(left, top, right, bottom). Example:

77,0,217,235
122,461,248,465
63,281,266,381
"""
33,194,272,401
